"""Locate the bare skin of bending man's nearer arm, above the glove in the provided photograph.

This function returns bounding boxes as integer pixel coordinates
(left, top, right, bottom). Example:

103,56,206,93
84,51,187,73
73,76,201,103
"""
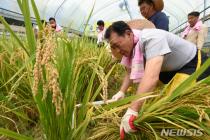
130,56,164,112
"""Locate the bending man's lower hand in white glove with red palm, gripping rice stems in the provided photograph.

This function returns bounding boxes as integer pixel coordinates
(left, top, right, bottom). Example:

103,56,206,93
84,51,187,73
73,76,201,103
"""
120,108,138,140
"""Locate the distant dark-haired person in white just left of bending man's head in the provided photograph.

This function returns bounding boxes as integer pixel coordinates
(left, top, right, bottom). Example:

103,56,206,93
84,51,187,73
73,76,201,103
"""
97,20,106,47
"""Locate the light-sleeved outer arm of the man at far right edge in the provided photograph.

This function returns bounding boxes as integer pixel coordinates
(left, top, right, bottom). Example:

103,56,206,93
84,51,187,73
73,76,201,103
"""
196,27,208,50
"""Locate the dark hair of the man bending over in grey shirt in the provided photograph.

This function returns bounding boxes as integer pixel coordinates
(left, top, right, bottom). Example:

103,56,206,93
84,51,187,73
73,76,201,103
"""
104,21,132,40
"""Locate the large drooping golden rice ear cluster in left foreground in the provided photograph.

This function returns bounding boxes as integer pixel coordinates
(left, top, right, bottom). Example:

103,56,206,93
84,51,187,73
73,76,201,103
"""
33,27,62,115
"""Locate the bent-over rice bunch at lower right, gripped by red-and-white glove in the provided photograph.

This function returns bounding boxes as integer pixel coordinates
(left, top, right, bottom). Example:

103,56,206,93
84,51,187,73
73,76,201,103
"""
89,59,210,140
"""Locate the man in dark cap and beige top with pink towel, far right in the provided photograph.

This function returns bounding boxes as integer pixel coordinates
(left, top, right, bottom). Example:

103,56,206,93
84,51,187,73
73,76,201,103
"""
181,11,208,50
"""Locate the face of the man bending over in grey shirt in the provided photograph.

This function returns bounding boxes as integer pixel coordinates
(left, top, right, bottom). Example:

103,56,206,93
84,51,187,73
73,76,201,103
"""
110,30,133,57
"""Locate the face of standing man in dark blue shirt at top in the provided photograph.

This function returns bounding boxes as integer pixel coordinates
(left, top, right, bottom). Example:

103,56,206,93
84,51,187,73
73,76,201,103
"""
140,2,153,19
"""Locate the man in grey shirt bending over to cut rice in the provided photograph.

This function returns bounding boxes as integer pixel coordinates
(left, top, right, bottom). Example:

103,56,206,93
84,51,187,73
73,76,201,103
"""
105,21,210,139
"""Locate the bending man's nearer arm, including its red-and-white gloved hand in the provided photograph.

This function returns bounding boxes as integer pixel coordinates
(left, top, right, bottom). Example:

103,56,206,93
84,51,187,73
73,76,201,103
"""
120,56,163,138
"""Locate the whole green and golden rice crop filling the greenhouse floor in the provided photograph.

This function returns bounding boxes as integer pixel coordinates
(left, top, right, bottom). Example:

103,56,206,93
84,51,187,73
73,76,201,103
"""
0,1,210,140
